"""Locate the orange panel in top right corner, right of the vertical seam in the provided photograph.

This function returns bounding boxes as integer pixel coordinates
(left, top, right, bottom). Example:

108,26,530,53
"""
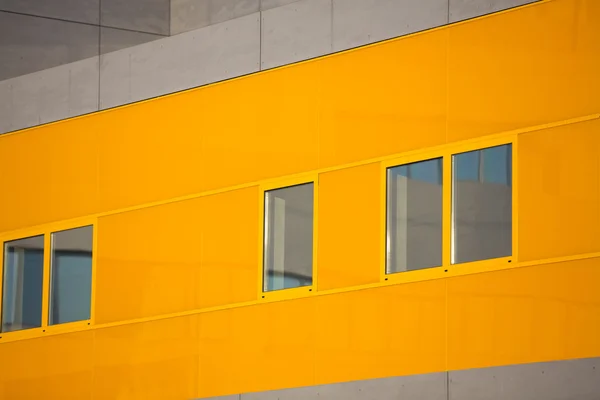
447,0,600,141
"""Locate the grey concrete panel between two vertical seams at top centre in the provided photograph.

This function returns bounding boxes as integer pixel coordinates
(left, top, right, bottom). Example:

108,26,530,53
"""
261,0,332,69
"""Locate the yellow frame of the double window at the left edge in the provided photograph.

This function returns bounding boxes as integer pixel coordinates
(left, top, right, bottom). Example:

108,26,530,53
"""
0,217,98,343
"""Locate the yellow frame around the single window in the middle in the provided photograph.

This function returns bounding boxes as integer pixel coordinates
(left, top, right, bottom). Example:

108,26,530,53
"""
257,173,319,300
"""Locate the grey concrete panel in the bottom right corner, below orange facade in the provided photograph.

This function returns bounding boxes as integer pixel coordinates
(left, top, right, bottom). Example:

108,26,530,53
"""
449,358,600,400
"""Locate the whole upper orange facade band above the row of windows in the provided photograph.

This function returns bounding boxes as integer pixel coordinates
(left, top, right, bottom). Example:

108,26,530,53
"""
0,0,600,231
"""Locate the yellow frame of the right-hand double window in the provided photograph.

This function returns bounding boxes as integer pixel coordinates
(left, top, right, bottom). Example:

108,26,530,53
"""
379,133,519,284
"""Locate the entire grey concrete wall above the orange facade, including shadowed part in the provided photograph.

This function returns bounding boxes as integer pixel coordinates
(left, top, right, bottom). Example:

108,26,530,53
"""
0,0,533,133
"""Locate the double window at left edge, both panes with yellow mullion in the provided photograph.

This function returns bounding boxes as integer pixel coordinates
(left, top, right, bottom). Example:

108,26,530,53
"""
0,225,93,333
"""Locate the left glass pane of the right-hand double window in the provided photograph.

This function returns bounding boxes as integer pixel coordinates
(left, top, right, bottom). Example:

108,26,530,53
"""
386,158,442,274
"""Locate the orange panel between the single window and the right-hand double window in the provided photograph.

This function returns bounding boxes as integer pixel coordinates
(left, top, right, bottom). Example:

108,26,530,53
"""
317,163,382,290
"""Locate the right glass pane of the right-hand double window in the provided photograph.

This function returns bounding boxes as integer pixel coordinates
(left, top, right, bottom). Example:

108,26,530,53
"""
452,144,512,264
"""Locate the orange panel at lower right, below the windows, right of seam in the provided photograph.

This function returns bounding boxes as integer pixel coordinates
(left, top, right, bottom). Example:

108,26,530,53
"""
446,258,600,370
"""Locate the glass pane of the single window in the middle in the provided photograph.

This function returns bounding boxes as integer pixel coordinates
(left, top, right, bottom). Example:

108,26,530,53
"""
263,183,314,292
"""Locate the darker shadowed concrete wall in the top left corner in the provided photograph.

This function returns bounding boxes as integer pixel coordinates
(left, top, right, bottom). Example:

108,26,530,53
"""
0,0,171,80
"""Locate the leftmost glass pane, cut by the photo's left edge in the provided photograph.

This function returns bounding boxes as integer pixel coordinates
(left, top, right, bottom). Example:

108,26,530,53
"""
2,235,44,332
